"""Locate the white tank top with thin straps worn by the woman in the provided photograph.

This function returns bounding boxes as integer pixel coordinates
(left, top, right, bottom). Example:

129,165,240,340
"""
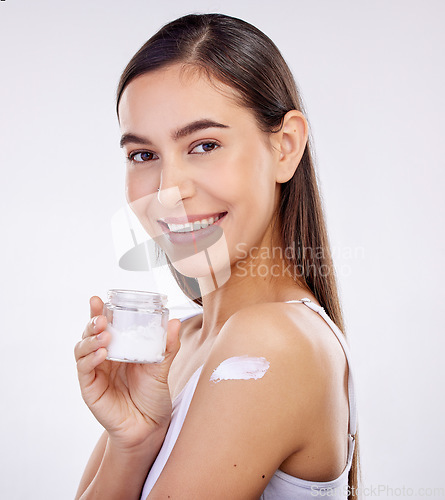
141,298,357,500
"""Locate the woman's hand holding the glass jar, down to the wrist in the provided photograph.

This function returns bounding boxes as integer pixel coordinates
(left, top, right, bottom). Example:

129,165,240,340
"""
74,296,181,450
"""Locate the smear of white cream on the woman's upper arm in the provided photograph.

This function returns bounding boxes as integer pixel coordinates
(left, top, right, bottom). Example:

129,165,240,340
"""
210,355,270,384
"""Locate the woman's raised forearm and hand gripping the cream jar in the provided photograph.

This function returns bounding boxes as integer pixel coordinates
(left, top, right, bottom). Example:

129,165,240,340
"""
74,297,180,500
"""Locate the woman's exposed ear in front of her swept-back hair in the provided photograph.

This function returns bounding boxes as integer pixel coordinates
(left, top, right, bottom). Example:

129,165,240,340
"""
272,109,308,183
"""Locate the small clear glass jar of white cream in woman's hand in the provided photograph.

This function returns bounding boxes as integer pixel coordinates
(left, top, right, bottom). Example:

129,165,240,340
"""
103,289,169,363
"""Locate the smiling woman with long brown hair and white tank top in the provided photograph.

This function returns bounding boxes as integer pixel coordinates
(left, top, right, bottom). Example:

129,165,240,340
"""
75,14,357,500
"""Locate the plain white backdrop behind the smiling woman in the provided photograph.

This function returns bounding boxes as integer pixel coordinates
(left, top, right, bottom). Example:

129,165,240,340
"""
0,0,445,500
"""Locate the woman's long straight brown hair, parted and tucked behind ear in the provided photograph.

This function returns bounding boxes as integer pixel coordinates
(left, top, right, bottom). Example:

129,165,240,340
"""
116,14,358,496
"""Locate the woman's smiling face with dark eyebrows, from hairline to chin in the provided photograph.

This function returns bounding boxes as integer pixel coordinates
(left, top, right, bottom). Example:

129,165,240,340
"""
119,65,279,277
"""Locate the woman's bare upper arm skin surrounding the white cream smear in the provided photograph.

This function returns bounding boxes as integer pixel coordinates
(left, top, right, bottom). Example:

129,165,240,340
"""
148,304,324,500
